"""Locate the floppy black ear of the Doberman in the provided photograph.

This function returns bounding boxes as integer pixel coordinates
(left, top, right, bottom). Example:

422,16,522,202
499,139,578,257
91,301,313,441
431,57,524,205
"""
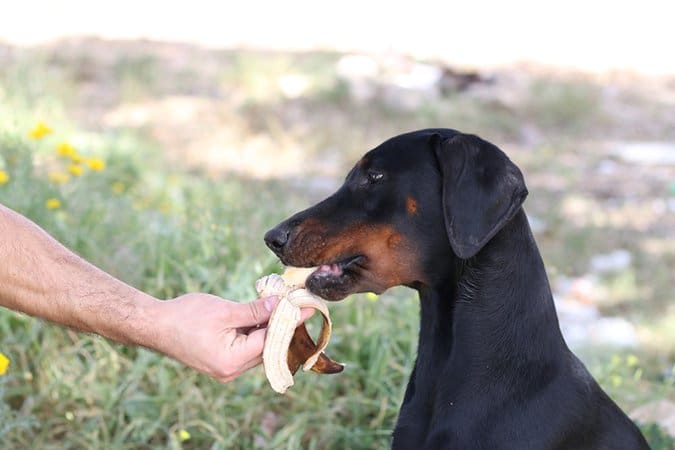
431,134,527,259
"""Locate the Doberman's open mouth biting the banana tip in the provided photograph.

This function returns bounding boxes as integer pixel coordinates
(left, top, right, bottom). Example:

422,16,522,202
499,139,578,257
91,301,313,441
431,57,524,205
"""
305,255,366,301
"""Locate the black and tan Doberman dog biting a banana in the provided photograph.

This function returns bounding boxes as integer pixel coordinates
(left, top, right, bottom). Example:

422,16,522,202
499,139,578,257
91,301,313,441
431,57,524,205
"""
265,129,649,450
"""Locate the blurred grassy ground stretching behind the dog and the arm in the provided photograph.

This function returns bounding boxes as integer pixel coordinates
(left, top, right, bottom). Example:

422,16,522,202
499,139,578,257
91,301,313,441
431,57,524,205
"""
0,39,675,449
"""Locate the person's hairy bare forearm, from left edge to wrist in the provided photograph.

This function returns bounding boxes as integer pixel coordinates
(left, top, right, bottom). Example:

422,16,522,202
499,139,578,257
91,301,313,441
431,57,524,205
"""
0,205,159,346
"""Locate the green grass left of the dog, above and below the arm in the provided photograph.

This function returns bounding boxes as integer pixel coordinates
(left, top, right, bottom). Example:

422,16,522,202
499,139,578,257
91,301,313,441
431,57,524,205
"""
0,120,417,448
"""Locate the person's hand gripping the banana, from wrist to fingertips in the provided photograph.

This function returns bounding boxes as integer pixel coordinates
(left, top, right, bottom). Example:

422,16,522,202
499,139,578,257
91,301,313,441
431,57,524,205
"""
151,293,313,383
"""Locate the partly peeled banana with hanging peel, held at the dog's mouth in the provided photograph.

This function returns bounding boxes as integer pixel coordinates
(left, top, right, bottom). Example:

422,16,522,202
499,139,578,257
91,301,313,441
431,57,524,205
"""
256,267,344,394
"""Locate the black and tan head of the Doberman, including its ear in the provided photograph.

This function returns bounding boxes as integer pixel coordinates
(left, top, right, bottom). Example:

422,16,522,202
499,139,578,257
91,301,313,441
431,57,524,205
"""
265,129,527,300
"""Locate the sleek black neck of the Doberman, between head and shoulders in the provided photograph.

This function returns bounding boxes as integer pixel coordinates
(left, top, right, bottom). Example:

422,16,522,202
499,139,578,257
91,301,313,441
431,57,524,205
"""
418,210,567,379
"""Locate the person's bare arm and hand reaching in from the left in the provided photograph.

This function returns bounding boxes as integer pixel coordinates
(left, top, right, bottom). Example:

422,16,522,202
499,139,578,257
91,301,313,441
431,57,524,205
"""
0,205,274,382
